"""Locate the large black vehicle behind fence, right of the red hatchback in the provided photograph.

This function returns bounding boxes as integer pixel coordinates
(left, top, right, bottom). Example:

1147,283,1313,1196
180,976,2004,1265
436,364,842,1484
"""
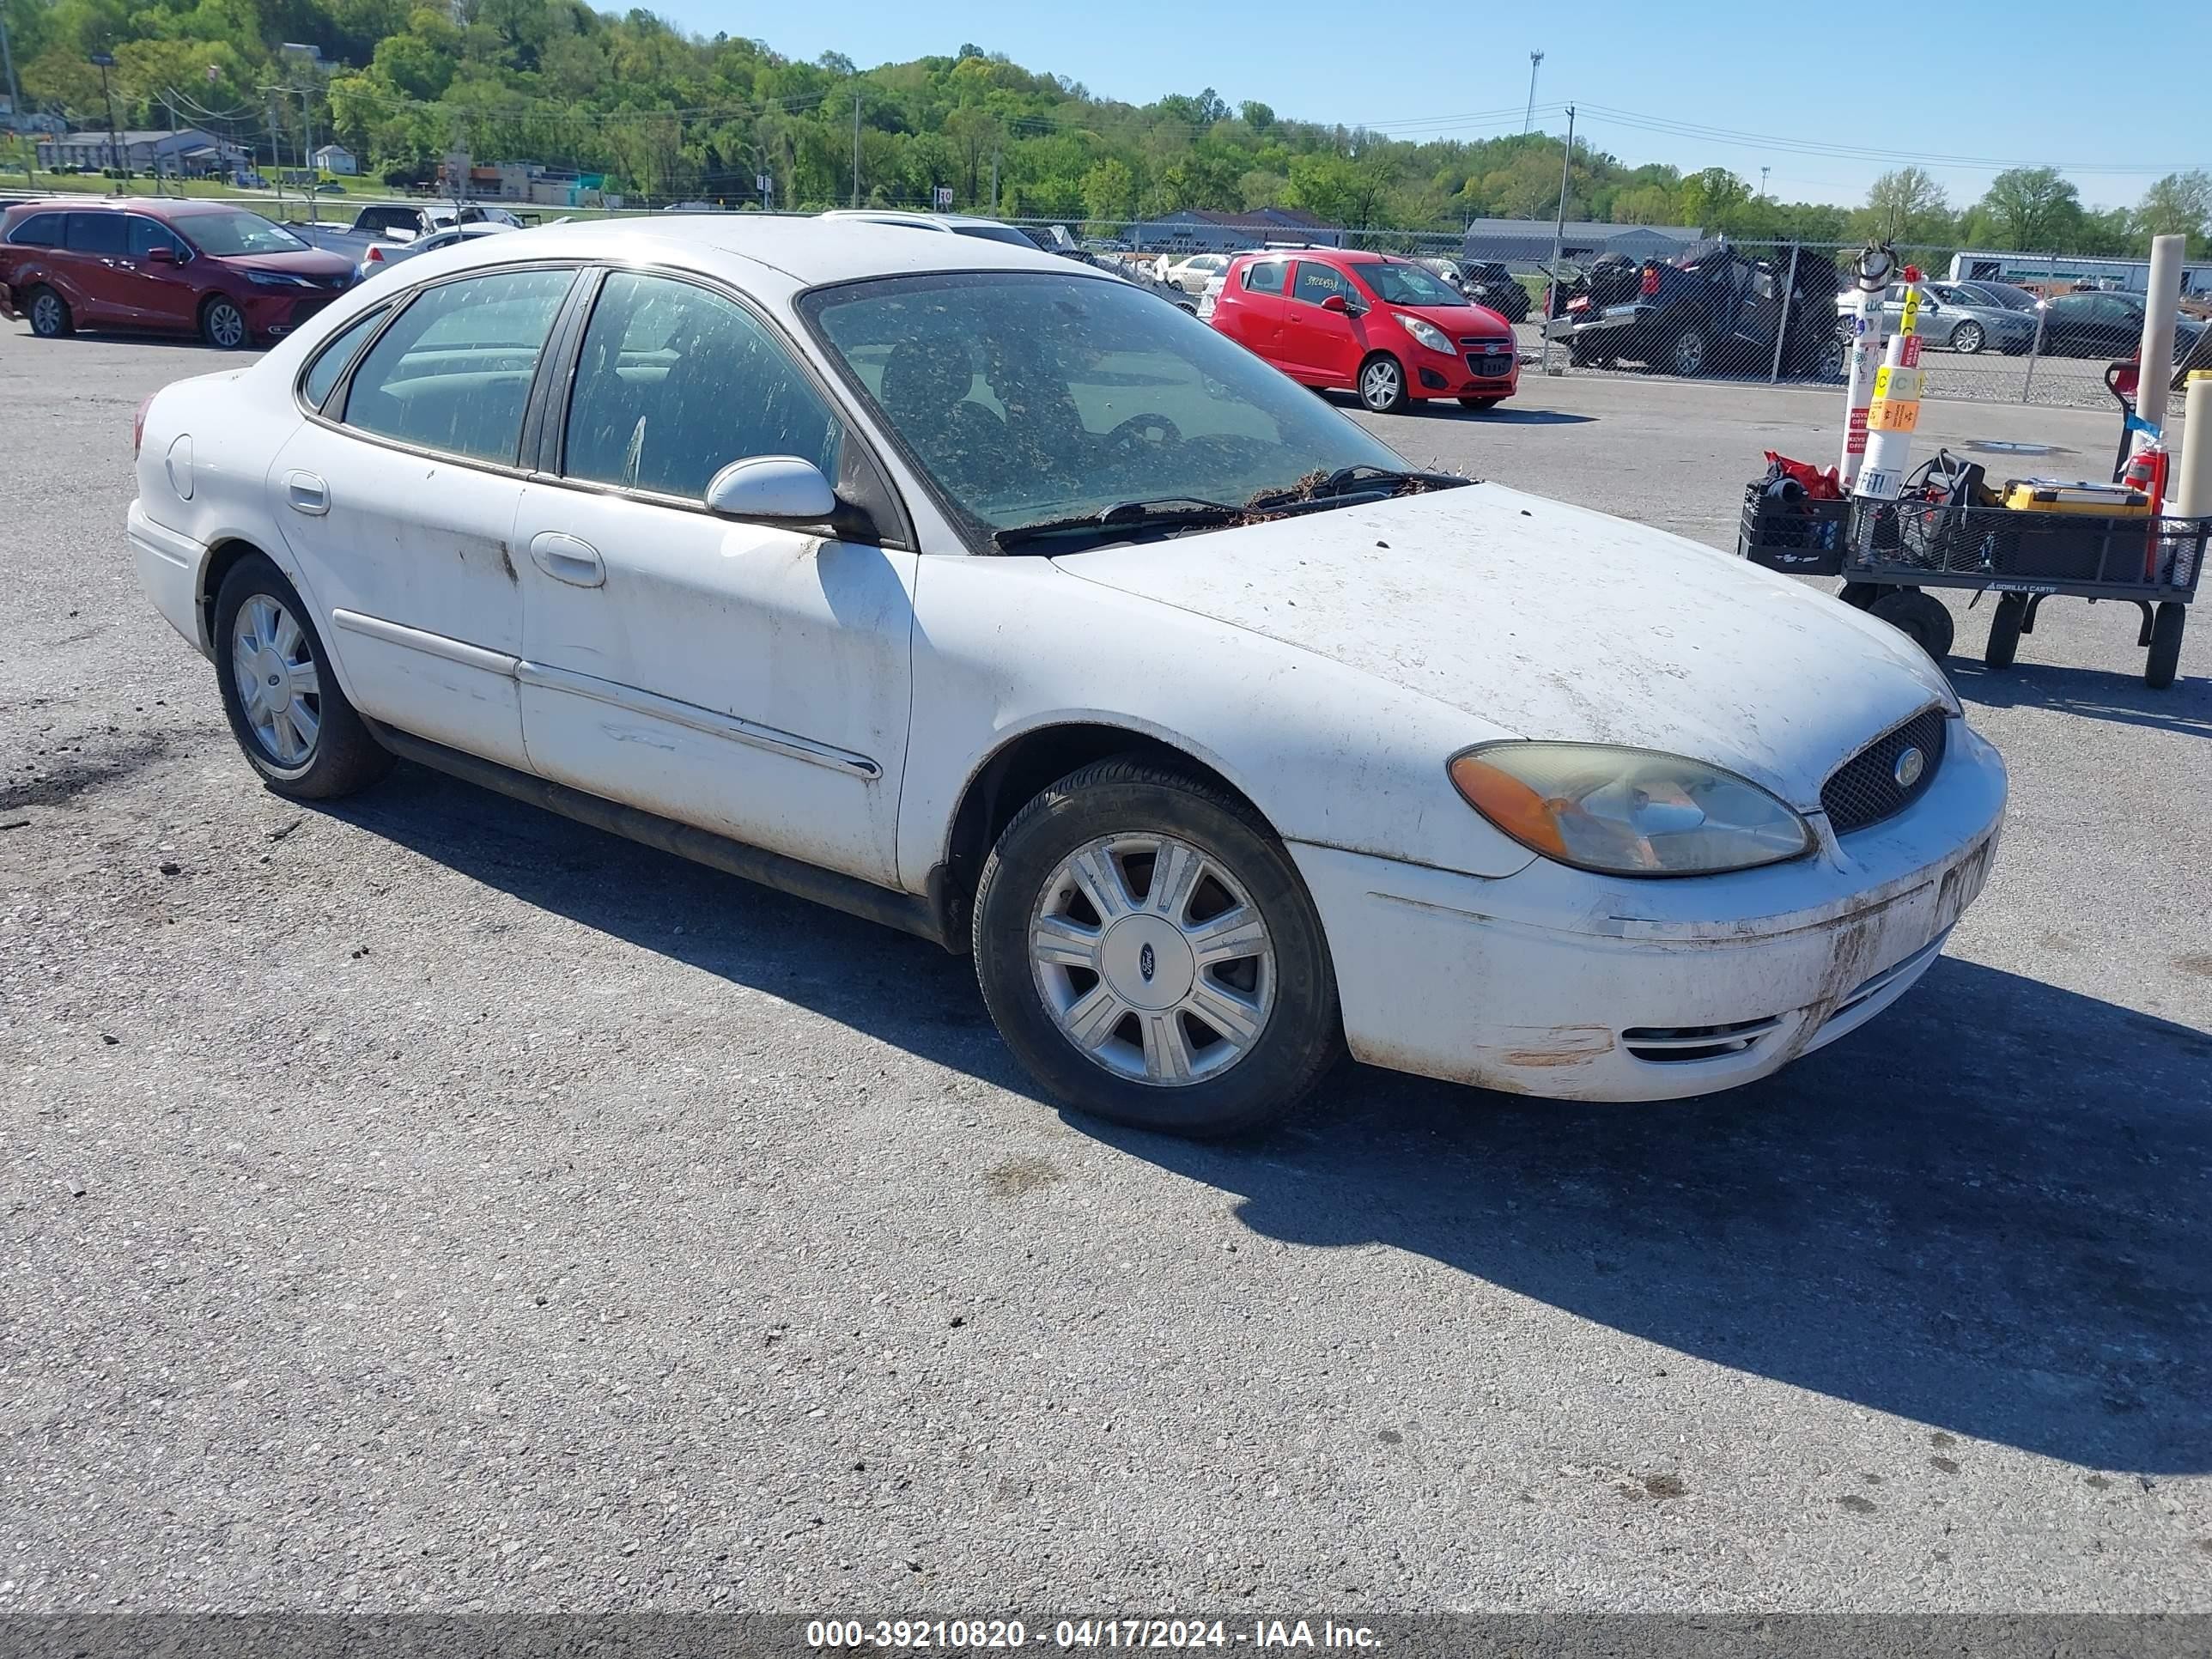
1551,246,1843,380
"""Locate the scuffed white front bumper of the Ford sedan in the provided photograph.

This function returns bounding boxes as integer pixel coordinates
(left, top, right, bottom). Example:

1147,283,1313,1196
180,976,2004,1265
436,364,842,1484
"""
1290,721,2006,1102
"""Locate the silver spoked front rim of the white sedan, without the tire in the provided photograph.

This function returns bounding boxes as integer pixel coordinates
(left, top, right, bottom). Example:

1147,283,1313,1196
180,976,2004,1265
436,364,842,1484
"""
1029,834,1276,1088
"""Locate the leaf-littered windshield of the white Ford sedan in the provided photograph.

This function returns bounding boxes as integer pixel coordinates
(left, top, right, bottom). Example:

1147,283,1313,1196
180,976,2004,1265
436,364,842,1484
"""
801,272,1405,540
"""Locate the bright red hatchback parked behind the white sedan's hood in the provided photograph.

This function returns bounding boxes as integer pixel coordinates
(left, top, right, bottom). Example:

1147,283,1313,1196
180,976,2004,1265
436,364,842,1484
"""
1212,248,1520,414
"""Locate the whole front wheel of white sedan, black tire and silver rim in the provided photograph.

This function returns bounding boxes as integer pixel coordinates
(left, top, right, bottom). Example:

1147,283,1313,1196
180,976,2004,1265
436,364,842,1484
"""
973,759,1343,1139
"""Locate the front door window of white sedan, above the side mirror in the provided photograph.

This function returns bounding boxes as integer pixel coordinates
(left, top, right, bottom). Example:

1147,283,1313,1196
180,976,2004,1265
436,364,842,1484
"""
562,272,842,500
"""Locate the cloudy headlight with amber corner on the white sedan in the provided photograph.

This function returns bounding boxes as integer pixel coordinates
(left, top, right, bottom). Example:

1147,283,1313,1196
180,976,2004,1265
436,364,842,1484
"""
1449,744,1814,876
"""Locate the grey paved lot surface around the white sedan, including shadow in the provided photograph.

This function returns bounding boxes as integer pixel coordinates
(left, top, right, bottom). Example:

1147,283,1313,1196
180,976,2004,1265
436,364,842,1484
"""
0,318,2212,1614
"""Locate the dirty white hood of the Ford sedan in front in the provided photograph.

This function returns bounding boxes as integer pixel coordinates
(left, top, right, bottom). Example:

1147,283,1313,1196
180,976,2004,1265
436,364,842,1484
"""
1055,484,1958,810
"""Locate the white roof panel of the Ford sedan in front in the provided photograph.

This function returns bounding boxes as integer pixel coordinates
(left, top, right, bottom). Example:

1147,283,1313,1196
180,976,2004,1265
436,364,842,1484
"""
393,212,1101,289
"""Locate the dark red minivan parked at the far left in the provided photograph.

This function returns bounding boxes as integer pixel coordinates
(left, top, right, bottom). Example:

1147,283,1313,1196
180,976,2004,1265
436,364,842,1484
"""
0,197,354,347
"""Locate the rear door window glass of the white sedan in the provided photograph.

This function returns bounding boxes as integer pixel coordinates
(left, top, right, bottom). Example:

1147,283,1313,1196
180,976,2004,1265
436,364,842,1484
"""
345,270,575,467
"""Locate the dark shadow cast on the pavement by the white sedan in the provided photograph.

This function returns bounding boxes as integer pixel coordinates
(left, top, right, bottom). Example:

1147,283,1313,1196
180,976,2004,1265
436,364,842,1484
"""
331,765,2212,1475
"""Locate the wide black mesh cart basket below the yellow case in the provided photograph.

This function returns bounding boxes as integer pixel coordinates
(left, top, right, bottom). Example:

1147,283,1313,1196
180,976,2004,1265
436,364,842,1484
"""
1840,500,2212,598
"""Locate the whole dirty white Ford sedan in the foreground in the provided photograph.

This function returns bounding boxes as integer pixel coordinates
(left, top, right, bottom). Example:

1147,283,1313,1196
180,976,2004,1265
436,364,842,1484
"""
131,215,2004,1134
